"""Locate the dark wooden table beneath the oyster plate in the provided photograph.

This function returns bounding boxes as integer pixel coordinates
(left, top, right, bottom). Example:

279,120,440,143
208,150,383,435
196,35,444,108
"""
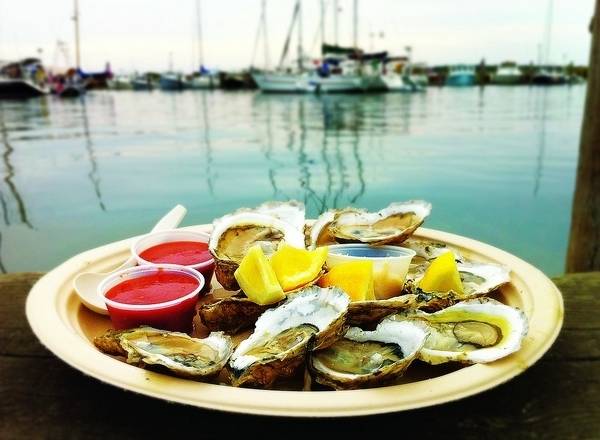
0,272,600,440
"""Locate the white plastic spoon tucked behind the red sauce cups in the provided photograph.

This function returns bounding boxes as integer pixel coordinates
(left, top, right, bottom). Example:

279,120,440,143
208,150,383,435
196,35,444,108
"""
73,205,187,315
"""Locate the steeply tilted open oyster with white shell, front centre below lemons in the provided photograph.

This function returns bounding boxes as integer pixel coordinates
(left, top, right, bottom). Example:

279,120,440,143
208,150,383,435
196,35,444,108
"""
229,286,350,387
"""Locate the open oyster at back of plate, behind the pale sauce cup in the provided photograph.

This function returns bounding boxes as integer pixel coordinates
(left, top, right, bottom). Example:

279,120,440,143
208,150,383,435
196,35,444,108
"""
329,200,431,245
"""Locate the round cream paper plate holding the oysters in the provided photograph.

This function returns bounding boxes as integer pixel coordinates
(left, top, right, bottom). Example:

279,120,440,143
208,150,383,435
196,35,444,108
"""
26,225,563,417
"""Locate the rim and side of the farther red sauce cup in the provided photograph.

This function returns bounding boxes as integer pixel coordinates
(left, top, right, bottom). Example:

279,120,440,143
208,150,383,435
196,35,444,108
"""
131,229,215,293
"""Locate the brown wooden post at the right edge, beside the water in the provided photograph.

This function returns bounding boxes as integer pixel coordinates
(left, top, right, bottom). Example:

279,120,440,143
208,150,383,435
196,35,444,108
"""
567,0,600,272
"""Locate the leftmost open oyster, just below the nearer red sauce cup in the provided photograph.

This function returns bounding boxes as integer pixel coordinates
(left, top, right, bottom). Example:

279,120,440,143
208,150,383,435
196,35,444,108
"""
94,327,233,377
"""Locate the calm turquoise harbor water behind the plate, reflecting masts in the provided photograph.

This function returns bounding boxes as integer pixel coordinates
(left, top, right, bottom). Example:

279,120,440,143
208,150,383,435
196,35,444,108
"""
0,86,585,274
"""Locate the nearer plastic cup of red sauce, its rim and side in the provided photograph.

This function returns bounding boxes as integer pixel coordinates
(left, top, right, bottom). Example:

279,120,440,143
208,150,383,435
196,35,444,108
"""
98,264,205,333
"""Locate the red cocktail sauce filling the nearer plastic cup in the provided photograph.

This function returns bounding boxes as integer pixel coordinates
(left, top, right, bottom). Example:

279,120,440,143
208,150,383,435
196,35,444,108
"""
105,269,200,332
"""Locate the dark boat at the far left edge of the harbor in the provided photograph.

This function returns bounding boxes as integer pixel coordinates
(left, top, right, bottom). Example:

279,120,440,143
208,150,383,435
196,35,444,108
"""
0,58,49,99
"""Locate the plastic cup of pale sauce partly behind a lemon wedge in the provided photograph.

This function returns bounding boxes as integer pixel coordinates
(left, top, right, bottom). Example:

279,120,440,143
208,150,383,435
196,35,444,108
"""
327,243,416,299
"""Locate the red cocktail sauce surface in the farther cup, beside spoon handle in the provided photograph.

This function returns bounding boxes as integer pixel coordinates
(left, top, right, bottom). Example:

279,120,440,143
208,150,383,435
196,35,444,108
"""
140,241,212,266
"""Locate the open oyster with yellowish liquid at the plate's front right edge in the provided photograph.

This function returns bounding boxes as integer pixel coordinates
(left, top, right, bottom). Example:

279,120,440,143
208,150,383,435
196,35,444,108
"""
386,298,528,364
